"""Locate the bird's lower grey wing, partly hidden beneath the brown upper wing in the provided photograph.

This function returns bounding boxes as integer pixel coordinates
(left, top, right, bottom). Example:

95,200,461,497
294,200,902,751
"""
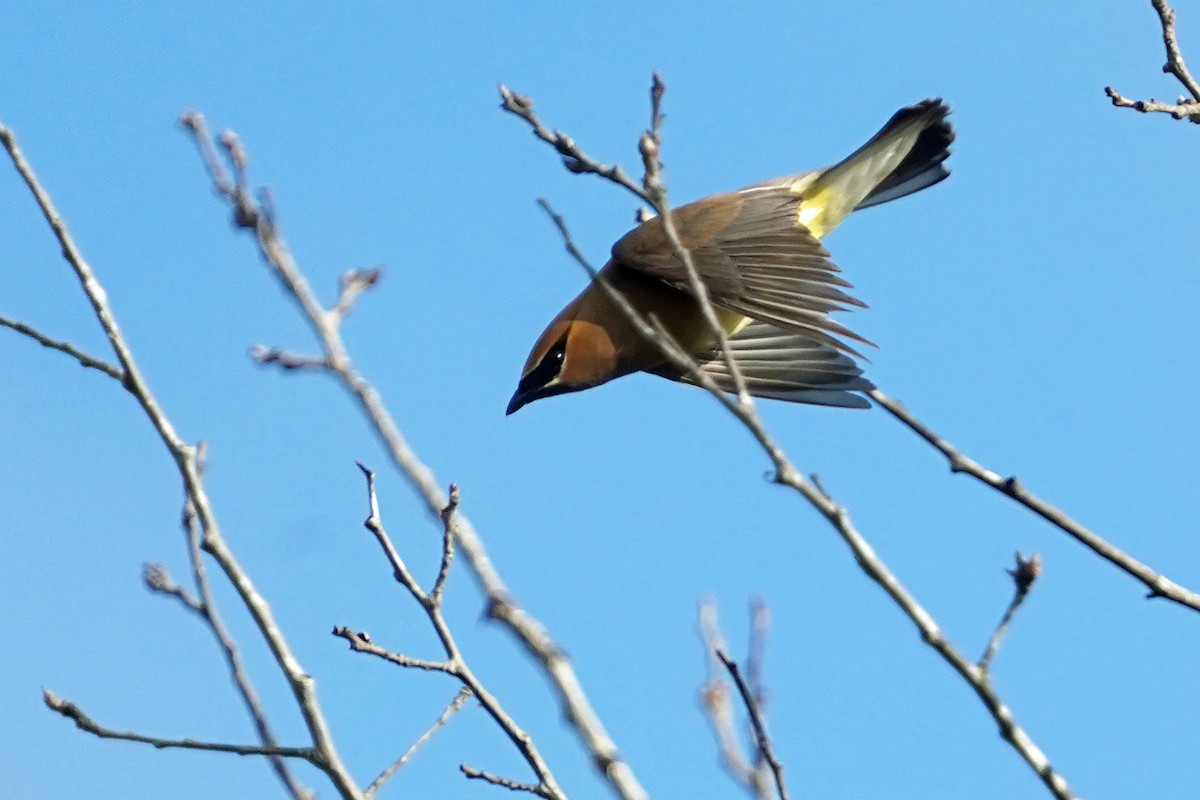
655,321,874,408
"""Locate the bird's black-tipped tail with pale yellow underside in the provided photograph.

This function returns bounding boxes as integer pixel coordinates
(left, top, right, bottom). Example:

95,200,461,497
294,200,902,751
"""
804,98,954,230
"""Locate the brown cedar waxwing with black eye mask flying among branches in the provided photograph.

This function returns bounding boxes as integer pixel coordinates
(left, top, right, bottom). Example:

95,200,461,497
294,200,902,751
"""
508,100,954,414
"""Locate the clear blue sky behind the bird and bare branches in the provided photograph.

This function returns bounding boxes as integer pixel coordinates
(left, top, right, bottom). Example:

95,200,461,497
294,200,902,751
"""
0,0,1200,800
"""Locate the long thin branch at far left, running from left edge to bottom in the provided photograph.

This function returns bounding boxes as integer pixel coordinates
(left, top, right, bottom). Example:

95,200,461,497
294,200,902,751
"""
0,115,361,800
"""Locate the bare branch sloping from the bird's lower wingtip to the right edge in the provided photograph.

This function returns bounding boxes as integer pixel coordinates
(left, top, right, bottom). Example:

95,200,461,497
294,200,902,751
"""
868,389,1200,610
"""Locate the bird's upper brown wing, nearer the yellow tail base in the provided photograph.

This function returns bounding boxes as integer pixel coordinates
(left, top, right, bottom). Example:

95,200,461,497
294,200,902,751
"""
612,185,870,355
